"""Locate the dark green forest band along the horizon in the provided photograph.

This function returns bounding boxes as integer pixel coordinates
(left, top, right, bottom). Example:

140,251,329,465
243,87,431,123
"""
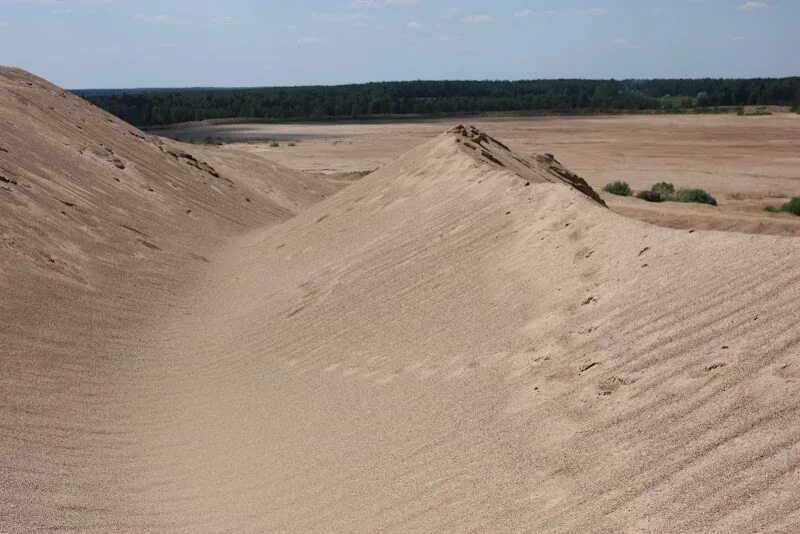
74,77,800,126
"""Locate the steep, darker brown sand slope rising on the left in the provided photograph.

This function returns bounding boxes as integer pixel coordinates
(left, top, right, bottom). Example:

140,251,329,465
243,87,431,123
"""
0,68,335,532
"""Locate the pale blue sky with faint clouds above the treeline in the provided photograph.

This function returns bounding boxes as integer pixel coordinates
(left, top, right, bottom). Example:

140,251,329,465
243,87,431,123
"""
0,0,800,89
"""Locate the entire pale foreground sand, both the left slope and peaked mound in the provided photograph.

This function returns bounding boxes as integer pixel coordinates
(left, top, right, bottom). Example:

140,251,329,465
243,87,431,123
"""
0,69,800,533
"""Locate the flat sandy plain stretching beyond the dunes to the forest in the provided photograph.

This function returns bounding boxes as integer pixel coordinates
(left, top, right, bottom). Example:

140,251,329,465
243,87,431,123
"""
154,113,800,235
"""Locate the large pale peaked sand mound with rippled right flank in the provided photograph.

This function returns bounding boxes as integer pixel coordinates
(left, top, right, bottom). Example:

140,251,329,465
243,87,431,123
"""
128,126,800,532
